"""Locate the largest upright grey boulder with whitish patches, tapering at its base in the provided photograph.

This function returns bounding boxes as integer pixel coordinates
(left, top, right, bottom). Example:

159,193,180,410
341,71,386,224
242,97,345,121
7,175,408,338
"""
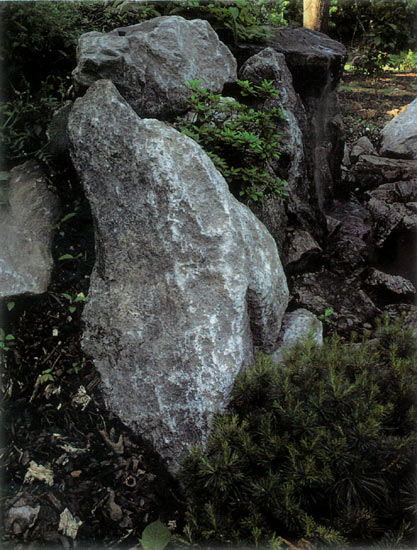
69,80,288,471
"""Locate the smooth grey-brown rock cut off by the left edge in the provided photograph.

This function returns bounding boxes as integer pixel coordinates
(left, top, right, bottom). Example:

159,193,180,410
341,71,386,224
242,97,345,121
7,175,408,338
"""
0,161,59,297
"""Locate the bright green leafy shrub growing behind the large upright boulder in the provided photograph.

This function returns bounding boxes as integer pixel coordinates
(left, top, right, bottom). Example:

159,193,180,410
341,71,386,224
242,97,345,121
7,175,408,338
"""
177,80,286,202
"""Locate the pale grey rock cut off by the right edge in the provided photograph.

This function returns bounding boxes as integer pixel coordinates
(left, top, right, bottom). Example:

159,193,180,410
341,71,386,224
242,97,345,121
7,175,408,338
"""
380,99,417,160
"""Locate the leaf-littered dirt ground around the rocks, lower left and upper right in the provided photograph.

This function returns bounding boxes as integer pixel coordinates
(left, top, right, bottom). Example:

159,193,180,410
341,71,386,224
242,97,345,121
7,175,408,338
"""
0,73,417,549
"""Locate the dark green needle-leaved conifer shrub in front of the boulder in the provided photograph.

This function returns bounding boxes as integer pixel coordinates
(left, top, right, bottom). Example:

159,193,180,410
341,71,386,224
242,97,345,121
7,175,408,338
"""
183,319,417,545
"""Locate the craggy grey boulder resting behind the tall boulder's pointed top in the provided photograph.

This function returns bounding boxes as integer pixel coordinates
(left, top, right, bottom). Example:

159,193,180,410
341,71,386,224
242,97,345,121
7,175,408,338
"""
73,16,236,118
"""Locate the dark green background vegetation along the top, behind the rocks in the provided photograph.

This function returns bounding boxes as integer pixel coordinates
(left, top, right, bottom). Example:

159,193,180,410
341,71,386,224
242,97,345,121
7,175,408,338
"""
0,0,417,171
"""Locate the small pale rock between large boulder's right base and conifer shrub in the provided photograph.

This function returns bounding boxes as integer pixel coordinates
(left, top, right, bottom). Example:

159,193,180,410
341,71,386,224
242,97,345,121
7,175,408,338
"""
271,308,323,363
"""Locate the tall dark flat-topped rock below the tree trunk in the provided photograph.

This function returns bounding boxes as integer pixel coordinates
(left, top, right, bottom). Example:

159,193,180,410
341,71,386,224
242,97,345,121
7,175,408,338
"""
236,27,347,209
